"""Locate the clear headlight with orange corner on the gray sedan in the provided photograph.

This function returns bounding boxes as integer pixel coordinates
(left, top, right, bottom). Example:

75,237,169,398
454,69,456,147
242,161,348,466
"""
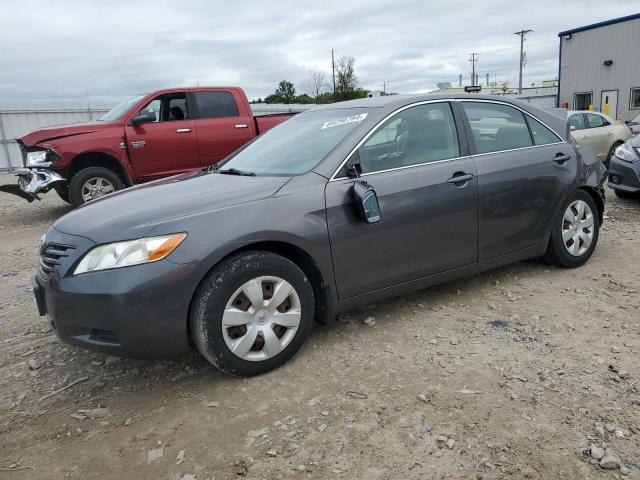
73,233,187,275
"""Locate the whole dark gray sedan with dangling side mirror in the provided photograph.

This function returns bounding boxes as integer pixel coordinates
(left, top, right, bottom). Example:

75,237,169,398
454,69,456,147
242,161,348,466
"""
33,95,605,375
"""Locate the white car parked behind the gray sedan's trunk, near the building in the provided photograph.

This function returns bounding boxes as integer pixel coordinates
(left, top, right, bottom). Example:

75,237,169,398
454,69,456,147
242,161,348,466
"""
567,110,633,167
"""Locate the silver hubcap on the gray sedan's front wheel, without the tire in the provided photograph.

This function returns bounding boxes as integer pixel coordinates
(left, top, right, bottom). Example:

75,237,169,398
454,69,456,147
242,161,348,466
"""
222,276,302,362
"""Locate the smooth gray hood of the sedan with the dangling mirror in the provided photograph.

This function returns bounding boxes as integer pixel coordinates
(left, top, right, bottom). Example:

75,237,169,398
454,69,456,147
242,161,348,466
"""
53,171,291,243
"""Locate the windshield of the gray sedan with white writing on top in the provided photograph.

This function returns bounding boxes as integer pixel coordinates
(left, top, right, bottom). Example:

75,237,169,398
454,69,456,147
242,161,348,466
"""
218,108,370,176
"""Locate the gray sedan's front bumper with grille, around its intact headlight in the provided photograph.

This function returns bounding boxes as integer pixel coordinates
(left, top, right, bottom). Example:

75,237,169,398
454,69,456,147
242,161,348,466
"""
33,228,197,358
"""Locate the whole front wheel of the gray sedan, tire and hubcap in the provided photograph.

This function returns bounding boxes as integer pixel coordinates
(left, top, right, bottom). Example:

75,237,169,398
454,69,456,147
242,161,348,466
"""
189,251,315,376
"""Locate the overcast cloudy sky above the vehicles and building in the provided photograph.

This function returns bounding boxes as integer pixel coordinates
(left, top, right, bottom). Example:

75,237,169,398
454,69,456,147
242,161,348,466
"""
0,0,640,105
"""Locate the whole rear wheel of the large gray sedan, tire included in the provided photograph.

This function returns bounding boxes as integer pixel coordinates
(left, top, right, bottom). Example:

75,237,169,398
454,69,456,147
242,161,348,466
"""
545,190,600,268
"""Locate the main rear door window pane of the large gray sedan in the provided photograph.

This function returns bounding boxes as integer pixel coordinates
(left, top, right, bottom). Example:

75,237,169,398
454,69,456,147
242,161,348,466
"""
462,102,533,153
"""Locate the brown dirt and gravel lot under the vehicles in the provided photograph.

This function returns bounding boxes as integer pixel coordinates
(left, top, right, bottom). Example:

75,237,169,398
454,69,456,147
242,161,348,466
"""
0,176,640,480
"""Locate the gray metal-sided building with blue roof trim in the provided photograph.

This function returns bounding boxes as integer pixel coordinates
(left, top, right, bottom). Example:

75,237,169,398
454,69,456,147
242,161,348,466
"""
557,13,640,121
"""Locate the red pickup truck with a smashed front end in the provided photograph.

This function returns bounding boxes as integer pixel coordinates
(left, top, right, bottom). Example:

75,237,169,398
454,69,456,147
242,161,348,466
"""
0,87,290,206
